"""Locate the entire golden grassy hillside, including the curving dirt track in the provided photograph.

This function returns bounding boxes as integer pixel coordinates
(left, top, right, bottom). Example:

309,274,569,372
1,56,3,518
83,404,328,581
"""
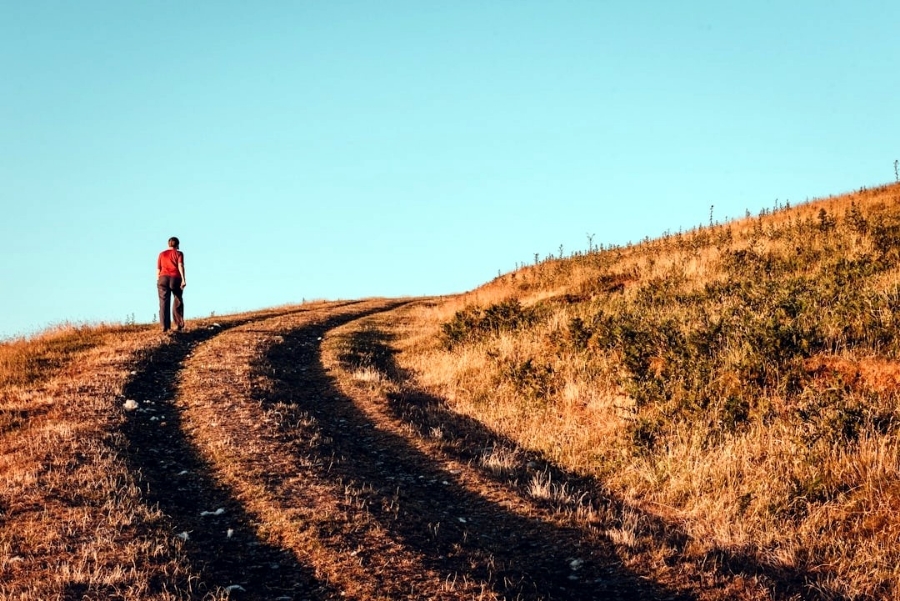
0,185,900,600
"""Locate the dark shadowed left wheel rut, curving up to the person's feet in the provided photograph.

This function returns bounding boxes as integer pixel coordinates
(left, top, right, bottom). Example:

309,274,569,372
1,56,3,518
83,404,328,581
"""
123,316,340,599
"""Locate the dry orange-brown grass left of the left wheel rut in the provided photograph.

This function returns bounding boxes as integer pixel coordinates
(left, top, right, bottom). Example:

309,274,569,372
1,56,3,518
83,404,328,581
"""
0,326,202,600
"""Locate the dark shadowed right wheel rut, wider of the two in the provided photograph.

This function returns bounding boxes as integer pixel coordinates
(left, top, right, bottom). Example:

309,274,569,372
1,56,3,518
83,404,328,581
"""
259,318,692,601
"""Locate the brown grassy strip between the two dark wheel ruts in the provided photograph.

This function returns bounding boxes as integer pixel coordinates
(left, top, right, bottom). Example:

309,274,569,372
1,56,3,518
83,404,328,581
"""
167,301,472,599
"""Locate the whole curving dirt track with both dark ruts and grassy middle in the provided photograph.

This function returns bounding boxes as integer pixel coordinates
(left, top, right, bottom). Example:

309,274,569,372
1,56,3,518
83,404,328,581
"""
125,300,688,600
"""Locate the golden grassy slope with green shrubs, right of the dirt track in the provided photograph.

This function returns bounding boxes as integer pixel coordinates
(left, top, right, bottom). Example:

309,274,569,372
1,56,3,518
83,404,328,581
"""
398,180,900,599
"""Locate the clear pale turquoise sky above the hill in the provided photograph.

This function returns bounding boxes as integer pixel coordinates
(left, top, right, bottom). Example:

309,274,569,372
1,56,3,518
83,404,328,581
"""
0,0,900,338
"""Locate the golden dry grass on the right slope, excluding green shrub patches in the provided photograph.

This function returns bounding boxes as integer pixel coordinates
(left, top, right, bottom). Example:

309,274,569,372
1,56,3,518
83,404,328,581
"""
400,186,900,599
